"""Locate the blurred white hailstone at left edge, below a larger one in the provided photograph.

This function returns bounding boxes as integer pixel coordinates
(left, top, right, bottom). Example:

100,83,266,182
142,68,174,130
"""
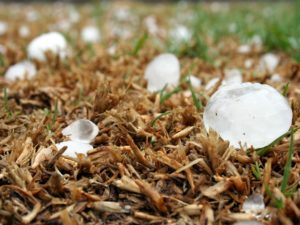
4,60,36,81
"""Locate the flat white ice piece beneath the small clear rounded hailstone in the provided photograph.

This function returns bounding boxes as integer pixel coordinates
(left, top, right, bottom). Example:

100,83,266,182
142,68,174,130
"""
55,141,93,158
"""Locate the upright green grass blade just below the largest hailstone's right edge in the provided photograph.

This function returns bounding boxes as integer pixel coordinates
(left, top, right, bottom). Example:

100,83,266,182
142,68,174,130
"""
281,129,295,193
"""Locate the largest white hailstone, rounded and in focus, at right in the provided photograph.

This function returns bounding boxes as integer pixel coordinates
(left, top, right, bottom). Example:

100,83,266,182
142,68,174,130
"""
203,83,293,148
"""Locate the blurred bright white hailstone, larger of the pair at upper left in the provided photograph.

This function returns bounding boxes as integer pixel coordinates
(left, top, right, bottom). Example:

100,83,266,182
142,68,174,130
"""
27,32,67,61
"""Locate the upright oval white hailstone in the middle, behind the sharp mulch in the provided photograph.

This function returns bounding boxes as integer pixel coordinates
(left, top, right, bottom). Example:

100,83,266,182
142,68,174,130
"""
145,53,180,92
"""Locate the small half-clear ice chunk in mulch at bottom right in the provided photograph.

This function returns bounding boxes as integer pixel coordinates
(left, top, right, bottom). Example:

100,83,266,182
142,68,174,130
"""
242,193,265,214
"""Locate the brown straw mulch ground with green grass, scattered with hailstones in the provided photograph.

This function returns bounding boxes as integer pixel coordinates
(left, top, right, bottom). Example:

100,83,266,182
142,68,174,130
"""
0,3,300,224
